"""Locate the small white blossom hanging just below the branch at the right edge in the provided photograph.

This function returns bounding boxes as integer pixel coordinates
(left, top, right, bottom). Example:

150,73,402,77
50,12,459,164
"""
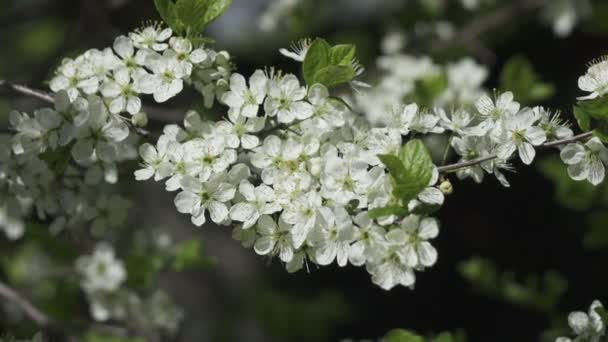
560,137,608,185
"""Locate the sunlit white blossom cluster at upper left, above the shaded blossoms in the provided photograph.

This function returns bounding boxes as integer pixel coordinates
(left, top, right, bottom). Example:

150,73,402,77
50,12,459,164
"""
50,25,232,115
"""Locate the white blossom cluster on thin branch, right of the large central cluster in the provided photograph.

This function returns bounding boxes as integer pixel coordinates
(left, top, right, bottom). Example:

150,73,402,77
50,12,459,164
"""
452,92,573,186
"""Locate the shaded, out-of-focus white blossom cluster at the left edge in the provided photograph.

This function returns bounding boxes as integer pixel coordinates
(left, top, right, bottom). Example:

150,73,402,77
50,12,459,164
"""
0,91,137,238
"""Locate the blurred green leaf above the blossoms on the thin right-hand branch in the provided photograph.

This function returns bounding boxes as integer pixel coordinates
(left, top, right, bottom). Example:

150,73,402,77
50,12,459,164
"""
500,55,555,104
